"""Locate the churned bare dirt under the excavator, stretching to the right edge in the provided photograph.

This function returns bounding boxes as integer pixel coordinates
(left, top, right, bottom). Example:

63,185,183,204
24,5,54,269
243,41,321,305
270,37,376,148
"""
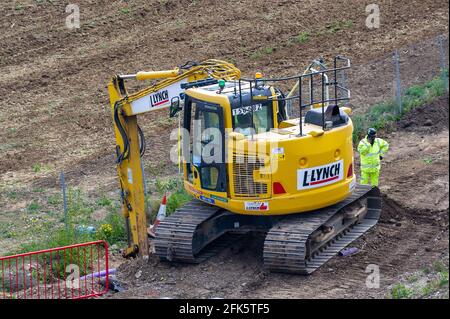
109,97,449,298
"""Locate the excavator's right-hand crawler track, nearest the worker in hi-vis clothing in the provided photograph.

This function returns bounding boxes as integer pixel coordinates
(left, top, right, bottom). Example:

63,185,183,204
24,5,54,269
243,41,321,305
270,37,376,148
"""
264,185,381,275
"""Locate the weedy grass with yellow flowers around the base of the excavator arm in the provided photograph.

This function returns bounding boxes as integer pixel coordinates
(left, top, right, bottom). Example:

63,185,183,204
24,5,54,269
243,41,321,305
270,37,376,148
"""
4,177,191,255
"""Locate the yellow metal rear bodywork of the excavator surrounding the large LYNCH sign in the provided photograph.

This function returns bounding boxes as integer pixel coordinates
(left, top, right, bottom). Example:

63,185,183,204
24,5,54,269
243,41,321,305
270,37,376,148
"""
186,116,355,215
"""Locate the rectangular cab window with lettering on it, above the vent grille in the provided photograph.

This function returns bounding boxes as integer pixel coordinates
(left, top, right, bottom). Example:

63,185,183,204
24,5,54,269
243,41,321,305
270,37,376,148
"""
232,103,273,136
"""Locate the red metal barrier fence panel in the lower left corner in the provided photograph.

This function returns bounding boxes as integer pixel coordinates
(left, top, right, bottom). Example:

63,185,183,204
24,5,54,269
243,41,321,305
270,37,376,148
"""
0,240,109,299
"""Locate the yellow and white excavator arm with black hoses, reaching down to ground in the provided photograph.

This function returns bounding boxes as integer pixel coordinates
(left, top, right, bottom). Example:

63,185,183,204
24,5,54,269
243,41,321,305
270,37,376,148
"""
108,60,241,258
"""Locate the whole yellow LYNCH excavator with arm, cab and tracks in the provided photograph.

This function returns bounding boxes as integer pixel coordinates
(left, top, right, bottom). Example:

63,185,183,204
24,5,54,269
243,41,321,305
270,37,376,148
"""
108,56,381,274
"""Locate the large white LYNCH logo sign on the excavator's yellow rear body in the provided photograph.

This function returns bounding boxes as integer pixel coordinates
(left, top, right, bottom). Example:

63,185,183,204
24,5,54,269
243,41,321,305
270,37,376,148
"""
297,160,344,190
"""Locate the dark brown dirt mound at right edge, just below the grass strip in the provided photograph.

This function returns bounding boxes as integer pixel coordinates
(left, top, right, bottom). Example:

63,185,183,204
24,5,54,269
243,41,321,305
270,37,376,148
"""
397,95,449,133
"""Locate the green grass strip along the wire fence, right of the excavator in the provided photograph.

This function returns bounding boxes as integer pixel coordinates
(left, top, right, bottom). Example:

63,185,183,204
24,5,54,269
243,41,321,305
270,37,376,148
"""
352,70,448,143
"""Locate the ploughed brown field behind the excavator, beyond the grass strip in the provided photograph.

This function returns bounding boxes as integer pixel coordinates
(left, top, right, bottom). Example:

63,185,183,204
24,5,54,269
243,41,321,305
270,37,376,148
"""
0,0,448,192
